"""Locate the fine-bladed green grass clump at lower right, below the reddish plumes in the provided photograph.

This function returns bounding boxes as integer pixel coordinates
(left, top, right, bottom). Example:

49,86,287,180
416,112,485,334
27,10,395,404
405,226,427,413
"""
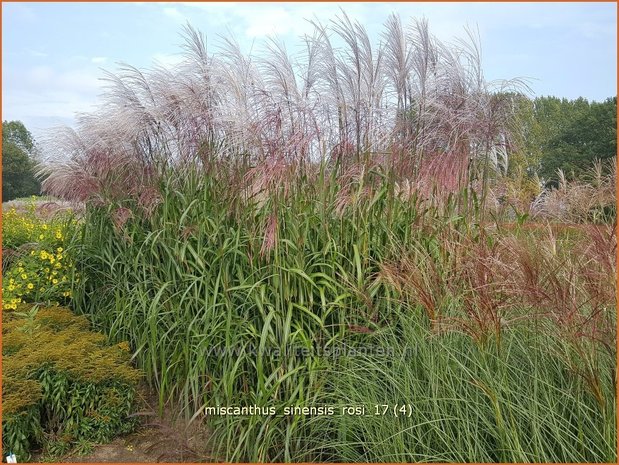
305,309,616,462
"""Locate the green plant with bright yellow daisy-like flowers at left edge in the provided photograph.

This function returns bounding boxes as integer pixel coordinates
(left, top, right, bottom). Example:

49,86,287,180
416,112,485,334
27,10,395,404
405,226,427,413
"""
2,197,79,310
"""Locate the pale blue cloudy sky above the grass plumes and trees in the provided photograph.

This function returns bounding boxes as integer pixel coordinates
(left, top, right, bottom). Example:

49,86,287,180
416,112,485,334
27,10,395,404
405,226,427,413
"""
2,2,617,137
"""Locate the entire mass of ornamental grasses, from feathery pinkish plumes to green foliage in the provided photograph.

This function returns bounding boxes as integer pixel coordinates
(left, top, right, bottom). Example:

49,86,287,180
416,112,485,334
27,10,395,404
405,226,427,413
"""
37,14,616,462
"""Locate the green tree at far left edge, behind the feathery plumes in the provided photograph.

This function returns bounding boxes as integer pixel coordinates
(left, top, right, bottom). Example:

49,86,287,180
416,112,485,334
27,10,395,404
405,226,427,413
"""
2,121,41,202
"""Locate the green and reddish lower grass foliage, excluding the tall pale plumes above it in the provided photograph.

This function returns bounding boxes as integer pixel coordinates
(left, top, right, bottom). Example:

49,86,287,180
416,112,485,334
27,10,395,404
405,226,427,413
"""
65,166,616,462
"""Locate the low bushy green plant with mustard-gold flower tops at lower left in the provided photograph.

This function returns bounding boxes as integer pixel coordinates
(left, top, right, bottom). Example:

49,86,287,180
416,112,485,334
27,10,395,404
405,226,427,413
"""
2,306,140,461
